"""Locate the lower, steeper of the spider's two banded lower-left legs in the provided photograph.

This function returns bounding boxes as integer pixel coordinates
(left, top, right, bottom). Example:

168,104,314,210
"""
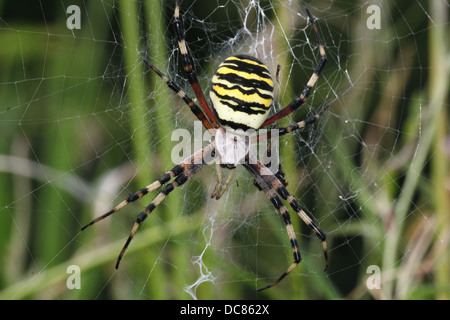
116,163,205,269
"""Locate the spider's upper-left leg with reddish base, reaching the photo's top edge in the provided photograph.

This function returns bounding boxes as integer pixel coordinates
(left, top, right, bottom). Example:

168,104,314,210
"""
174,0,219,128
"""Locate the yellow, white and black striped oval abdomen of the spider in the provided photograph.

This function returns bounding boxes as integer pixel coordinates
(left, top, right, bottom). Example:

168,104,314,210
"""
209,55,273,130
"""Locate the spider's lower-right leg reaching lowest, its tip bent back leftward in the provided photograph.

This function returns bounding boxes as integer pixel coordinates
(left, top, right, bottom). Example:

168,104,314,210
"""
244,164,302,291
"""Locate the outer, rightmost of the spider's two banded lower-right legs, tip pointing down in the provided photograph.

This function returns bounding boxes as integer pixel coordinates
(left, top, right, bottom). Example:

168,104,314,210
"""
250,160,328,271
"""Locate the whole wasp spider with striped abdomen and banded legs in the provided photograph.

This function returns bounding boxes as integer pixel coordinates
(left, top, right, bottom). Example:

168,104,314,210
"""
81,0,328,291
